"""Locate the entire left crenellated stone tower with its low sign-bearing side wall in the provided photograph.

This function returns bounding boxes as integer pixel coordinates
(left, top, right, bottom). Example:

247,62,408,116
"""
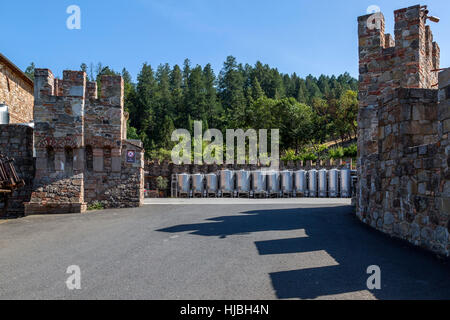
25,69,144,214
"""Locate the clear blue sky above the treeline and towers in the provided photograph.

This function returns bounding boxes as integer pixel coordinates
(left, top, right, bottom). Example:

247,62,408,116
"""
0,0,450,78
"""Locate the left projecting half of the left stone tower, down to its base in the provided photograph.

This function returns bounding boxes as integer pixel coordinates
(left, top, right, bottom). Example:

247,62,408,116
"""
25,69,86,214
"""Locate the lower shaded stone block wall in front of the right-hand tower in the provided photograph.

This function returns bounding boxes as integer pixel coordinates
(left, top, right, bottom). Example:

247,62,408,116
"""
358,88,450,255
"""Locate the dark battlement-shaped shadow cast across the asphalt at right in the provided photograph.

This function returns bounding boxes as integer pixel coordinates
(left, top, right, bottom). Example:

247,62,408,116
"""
158,206,450,299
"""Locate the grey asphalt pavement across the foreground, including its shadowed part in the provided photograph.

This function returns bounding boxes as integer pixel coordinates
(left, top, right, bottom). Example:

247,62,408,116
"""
0,202,450,299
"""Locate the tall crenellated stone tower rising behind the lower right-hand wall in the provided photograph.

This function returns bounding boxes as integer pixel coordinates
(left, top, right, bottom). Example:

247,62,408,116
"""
358,5,440,157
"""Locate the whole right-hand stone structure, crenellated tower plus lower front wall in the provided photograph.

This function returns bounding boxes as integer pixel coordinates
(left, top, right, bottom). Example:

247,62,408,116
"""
356,5,450,256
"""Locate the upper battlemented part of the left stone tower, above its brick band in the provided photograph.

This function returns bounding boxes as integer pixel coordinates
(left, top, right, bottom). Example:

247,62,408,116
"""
34,69,126,149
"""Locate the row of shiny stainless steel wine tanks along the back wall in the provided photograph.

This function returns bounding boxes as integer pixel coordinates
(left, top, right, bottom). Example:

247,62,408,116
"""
176,169,352,198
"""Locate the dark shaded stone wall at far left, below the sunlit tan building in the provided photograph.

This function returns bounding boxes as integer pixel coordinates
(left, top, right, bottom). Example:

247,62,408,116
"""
0,125,34,216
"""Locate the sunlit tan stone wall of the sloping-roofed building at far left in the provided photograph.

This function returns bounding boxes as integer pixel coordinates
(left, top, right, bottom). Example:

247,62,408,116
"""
0,54,34,124
